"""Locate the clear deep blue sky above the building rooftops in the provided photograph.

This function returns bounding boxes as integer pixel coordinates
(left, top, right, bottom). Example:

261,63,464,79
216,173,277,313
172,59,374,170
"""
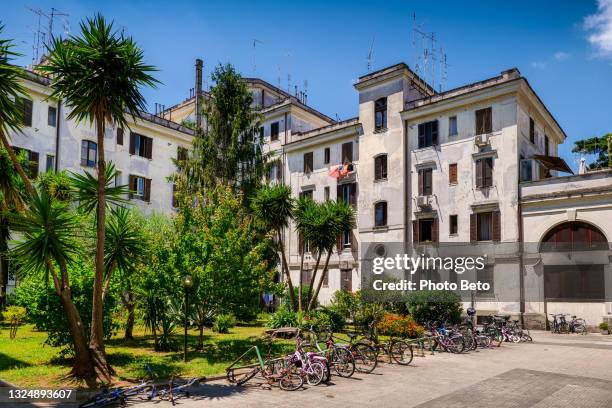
0,0,612,168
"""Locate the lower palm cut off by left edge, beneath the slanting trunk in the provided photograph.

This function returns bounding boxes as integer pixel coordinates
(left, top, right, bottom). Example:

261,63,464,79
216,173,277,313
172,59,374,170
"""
0,146,26,310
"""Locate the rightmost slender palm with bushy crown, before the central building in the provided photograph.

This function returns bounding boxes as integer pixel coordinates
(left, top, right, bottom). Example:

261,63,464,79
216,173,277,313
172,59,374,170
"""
308,201,355,310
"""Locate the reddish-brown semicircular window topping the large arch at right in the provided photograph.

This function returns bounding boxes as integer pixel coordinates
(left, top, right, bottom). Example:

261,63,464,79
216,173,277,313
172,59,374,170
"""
540,221,608,252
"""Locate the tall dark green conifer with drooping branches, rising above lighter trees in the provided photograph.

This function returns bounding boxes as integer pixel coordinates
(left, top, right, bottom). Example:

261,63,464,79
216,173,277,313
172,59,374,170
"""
177,64,265,203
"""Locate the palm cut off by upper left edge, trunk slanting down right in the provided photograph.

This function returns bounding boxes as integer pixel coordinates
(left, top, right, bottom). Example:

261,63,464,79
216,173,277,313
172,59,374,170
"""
0,24,34,194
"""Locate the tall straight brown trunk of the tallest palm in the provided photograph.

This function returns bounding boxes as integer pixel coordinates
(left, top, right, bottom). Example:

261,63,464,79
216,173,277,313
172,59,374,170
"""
89,112,112,378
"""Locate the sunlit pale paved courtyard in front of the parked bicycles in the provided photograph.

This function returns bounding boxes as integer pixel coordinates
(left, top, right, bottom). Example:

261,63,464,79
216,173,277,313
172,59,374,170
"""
124,332,612,408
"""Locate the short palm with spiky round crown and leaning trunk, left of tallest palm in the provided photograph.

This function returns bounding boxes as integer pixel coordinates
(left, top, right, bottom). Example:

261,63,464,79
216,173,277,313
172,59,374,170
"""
10,191,96,387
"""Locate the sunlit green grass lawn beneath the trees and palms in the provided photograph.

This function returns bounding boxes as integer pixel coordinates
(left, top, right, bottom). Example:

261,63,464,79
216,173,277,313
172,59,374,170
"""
0,325,294,387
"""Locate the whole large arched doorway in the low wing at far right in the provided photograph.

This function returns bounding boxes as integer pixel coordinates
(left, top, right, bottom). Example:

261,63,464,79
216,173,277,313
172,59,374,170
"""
540,221,609,320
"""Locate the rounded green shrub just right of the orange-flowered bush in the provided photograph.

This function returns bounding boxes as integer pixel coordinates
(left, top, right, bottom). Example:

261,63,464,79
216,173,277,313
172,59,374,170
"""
406,290,463,324
